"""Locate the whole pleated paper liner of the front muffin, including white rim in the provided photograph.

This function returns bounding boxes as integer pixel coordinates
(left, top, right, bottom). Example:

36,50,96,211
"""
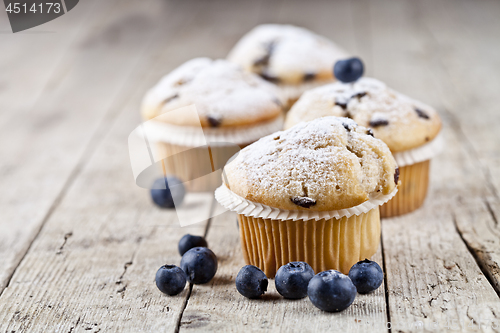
215,185,397,277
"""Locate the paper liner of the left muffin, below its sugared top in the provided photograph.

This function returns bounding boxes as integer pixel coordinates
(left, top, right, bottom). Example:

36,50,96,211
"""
141,115,283,192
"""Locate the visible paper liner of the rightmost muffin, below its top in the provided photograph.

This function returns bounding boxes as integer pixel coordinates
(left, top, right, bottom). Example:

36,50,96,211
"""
380,135,443,217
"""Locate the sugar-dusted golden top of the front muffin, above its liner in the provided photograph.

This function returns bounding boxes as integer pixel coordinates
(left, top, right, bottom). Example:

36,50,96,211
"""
223,117,399,211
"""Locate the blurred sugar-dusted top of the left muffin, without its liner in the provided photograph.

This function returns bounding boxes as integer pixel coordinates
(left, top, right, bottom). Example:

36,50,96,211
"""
142,58,282,128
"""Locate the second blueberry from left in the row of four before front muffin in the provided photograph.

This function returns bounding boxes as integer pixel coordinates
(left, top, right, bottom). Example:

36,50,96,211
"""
274,261,314,299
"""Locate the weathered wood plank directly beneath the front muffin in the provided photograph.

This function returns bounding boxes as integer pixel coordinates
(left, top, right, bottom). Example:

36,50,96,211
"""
180,205,387,332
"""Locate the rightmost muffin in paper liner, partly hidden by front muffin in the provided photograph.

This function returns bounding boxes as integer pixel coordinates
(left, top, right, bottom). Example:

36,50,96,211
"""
285,78,441,217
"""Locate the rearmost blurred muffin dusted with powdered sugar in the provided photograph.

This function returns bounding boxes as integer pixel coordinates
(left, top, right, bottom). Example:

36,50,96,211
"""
227,24,347,108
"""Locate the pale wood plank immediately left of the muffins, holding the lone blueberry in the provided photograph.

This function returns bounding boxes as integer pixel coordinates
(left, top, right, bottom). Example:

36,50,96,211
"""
0,3,258,332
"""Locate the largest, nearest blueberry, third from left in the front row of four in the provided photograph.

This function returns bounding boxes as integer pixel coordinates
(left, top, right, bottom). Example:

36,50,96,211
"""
307,269,356,312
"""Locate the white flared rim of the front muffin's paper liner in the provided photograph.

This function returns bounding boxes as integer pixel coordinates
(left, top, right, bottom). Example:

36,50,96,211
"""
215,184,398,221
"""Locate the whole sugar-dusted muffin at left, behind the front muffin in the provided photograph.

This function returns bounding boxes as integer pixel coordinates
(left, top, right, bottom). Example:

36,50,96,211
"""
142,58,283,191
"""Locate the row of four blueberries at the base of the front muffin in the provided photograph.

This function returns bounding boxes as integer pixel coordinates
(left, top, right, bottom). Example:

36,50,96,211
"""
236,259,384,312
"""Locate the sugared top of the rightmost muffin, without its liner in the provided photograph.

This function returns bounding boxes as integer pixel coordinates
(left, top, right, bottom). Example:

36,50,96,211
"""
285,77,441,153
